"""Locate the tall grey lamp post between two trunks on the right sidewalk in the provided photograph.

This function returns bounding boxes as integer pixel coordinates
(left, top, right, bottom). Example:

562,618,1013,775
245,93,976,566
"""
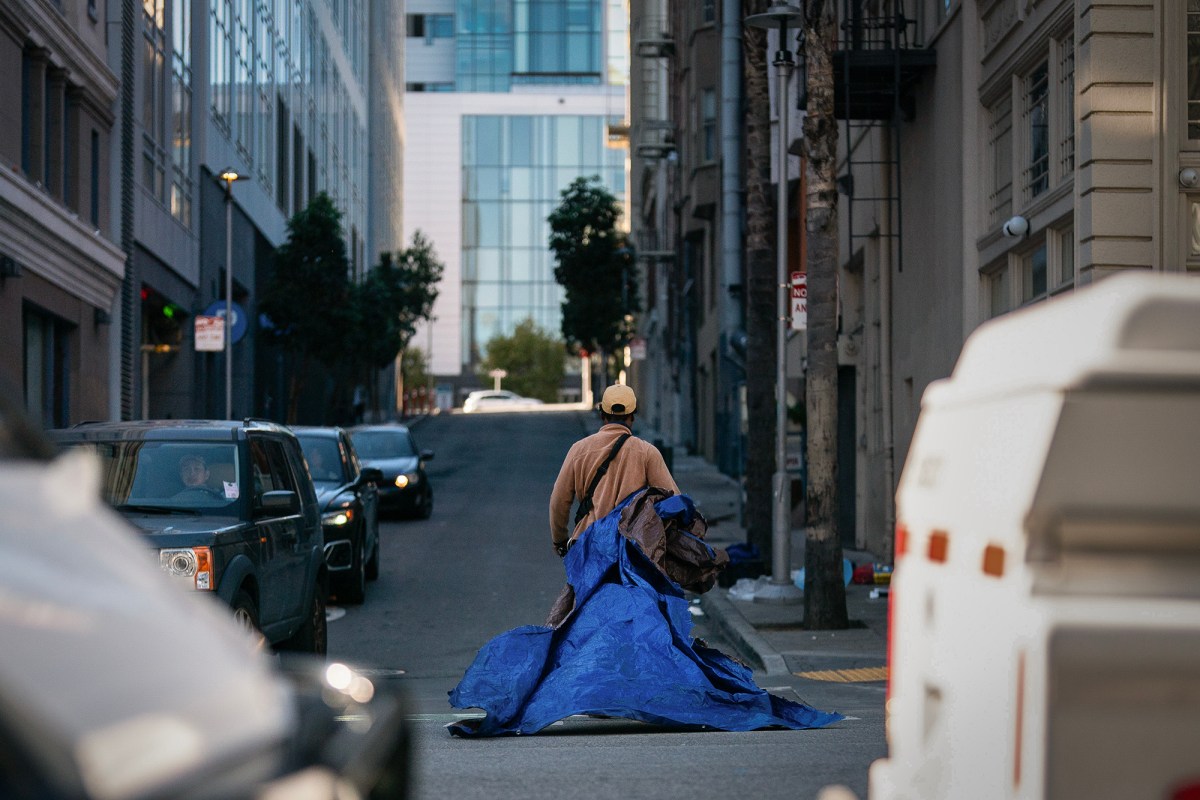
745,2,804,603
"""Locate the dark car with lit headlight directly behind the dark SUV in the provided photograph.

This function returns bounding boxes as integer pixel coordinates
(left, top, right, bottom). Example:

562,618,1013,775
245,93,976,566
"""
292,426,383,604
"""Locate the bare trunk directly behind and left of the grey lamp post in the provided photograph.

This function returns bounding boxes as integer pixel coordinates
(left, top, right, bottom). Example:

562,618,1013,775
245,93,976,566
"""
743,0,779,564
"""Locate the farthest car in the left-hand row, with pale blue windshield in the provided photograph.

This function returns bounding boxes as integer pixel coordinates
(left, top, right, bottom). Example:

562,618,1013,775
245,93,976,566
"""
350,425,433,519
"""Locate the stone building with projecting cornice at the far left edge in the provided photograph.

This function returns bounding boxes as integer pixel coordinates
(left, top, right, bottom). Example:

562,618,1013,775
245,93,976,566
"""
0,0,125,427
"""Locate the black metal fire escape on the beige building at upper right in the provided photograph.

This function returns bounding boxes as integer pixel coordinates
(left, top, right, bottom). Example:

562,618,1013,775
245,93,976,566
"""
833,0,937,271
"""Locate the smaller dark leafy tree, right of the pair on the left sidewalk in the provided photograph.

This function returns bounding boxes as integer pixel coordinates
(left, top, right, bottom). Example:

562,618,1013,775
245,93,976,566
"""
348,230,445,414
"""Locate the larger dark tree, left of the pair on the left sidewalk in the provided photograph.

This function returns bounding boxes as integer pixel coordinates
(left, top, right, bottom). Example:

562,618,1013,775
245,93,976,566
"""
258,192,352,423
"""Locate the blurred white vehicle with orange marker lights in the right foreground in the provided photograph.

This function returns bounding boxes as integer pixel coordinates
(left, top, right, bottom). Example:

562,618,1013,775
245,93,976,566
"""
870,273,1200,800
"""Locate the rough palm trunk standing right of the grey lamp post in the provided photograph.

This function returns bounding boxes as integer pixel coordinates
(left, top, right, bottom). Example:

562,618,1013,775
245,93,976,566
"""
804,0,848,630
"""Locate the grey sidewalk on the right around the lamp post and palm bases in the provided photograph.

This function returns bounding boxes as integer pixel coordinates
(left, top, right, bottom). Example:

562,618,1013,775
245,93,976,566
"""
672,452,888,680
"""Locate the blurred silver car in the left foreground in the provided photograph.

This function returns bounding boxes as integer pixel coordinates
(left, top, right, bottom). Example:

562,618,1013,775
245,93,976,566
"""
0,393,410,800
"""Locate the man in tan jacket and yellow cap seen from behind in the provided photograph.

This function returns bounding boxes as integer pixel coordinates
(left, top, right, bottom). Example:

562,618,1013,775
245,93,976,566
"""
550,384,679,557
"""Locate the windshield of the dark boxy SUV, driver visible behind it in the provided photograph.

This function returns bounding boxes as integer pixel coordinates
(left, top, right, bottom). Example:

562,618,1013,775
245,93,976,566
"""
69,440,241,515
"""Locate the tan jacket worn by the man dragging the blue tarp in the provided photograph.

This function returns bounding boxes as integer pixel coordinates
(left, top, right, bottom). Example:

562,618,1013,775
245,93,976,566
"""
550,422,679,545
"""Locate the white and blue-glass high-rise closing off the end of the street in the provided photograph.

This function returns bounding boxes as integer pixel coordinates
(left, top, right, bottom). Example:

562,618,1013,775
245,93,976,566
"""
404,0,628,403
